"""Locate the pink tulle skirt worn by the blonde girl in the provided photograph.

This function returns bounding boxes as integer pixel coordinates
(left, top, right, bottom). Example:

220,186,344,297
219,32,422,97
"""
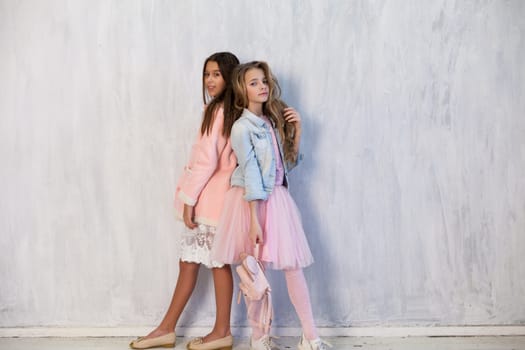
211,186,313,270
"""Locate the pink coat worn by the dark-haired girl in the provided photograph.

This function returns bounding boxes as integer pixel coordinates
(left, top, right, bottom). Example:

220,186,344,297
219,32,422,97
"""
175,107,237,226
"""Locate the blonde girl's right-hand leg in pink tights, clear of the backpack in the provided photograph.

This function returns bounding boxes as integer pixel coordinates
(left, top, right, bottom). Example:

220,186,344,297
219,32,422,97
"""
284,269,318,340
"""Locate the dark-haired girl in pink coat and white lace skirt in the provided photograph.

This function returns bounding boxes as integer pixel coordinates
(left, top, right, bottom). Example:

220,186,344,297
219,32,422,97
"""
130,52,239,350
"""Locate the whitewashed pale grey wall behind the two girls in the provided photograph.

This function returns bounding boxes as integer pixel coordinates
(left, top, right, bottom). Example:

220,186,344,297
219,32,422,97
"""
0,0,525,327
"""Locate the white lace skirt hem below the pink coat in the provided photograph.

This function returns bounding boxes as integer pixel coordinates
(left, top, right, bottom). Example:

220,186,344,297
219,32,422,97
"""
180,224,224,269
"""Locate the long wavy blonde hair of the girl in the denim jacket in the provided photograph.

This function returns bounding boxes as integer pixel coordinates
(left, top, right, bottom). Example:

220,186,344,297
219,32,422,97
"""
233,61,297,163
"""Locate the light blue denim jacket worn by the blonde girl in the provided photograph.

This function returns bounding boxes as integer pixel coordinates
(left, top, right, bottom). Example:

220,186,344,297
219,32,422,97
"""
230,109,300,201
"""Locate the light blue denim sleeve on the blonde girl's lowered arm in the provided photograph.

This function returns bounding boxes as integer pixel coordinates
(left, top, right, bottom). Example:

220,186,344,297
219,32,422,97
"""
230,123,268,201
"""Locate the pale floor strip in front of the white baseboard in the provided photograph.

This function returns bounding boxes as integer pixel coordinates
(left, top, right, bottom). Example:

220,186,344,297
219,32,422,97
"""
0,336,525,350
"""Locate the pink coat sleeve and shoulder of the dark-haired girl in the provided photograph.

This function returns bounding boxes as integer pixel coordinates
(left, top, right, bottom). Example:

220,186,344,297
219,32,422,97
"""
176,108,224,206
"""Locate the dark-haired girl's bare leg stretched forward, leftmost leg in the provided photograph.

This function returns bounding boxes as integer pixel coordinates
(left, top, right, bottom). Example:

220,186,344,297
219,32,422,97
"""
146,261,200,338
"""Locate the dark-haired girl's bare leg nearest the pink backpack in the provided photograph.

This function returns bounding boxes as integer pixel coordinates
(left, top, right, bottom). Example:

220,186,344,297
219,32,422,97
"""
203,265,233,343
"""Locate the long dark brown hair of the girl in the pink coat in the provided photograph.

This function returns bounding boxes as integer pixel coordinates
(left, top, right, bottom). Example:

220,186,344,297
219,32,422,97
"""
201,52,239,137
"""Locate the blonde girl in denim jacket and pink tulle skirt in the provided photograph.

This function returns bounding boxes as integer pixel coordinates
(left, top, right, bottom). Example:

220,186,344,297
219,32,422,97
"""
212,61,327,350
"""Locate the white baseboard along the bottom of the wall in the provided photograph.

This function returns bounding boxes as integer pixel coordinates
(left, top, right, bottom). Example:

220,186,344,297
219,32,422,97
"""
0,325,525,338
